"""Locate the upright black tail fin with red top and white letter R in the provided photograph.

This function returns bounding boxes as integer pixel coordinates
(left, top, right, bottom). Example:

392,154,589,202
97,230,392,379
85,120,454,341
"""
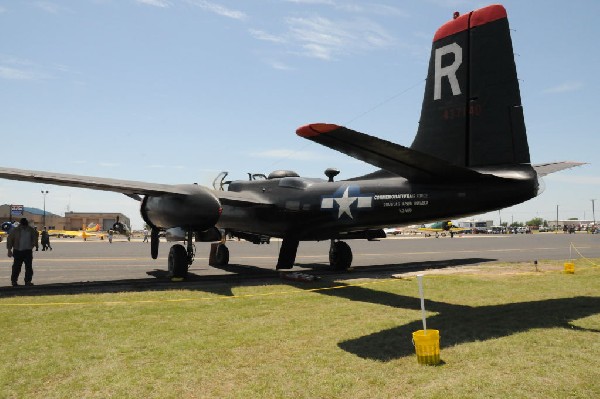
411,5,530,167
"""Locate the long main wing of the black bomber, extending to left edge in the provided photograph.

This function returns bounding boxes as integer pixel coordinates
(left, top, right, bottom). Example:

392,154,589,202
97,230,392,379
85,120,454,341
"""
0,167,272,206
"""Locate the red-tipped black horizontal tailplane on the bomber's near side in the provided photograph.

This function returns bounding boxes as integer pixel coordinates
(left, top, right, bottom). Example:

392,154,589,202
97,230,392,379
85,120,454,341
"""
296,123,500,182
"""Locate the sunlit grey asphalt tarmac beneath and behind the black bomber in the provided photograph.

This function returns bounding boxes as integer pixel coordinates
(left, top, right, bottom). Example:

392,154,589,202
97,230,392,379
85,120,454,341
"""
0,233,600,295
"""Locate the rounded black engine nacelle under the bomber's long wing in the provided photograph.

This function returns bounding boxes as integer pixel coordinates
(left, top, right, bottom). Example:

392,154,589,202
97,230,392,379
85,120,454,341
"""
141,185,222,231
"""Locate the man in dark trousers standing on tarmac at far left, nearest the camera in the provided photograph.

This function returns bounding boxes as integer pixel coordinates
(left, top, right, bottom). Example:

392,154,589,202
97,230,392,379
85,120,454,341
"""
6,218,38,287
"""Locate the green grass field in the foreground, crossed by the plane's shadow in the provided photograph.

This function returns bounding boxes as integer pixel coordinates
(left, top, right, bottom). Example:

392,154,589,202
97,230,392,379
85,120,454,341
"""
0,262,600,398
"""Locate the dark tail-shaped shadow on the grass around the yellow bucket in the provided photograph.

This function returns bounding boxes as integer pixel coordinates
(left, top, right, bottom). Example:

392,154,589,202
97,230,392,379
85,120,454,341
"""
330,287,600,362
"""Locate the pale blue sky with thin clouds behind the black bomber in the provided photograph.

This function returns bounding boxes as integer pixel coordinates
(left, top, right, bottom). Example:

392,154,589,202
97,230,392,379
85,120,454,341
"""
0,0,600,228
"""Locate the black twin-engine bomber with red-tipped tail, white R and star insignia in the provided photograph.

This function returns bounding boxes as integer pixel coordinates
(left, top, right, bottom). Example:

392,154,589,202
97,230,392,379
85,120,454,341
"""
0,5,581,277
